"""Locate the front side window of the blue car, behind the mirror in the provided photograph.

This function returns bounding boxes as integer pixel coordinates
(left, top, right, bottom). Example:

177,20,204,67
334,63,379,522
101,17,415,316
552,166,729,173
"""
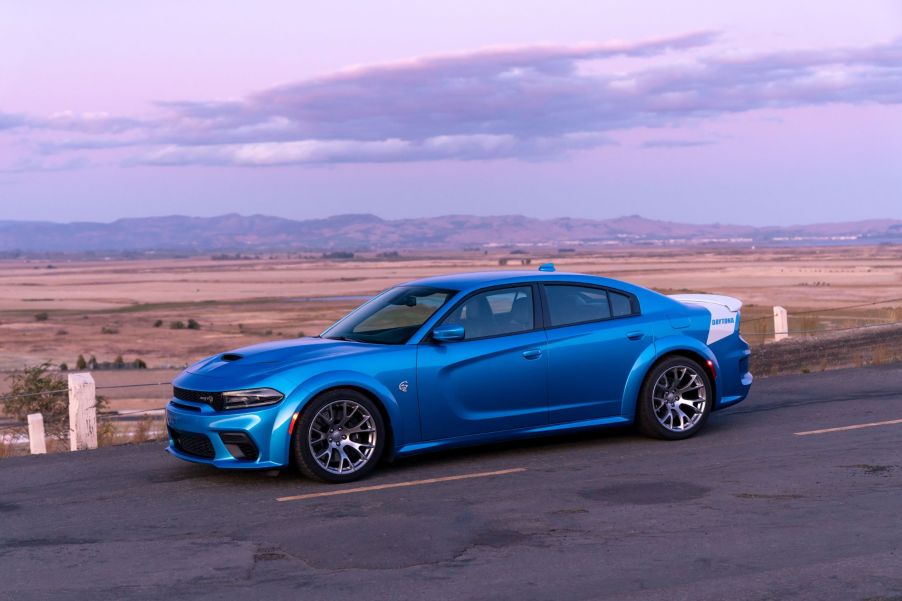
442,286,535,340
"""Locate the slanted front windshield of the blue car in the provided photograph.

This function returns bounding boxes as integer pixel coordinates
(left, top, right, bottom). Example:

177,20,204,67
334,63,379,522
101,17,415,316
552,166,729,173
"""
321,286,455,344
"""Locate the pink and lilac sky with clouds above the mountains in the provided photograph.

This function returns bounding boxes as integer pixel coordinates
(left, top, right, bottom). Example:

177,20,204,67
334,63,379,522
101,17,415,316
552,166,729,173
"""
0,1,902,224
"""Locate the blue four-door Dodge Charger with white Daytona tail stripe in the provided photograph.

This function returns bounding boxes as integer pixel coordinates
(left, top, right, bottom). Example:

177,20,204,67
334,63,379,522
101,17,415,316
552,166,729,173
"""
166,264,752,482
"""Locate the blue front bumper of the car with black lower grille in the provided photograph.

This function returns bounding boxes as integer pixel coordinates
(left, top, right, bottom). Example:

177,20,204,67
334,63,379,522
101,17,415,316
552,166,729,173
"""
166,400,285,469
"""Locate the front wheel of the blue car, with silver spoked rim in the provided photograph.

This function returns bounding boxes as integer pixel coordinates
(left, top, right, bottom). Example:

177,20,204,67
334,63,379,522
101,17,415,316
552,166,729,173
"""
291,390,385,483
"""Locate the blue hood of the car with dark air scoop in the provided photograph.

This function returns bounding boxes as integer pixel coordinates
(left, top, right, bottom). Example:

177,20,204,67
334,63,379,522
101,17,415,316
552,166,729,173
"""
185,338,384,378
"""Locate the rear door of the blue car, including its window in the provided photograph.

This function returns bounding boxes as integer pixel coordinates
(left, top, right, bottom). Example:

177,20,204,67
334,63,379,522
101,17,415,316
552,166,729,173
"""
543,283,653,423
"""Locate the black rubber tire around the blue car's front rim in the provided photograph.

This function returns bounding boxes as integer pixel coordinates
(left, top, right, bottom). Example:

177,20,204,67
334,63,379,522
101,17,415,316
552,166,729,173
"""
291,389,386,484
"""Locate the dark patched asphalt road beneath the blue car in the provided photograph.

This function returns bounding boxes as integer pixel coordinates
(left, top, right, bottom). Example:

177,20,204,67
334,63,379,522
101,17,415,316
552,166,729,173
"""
0,365,902,601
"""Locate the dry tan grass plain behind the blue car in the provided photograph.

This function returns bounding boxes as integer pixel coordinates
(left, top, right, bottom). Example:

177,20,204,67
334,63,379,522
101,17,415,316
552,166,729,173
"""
0,246,902,409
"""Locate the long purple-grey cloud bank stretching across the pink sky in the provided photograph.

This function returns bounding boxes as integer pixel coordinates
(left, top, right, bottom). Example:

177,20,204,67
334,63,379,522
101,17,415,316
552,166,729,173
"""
0,32,902,166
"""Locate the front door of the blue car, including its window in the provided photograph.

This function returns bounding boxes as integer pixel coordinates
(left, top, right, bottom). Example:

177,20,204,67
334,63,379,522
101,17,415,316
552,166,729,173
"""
417,284,548,440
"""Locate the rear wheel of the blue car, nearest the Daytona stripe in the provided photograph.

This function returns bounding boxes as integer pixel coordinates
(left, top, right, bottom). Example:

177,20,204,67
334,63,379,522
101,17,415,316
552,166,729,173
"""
637,357,714,440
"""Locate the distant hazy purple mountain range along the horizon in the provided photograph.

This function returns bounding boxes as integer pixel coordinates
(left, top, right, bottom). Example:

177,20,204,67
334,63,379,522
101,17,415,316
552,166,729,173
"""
0,214,902,255
